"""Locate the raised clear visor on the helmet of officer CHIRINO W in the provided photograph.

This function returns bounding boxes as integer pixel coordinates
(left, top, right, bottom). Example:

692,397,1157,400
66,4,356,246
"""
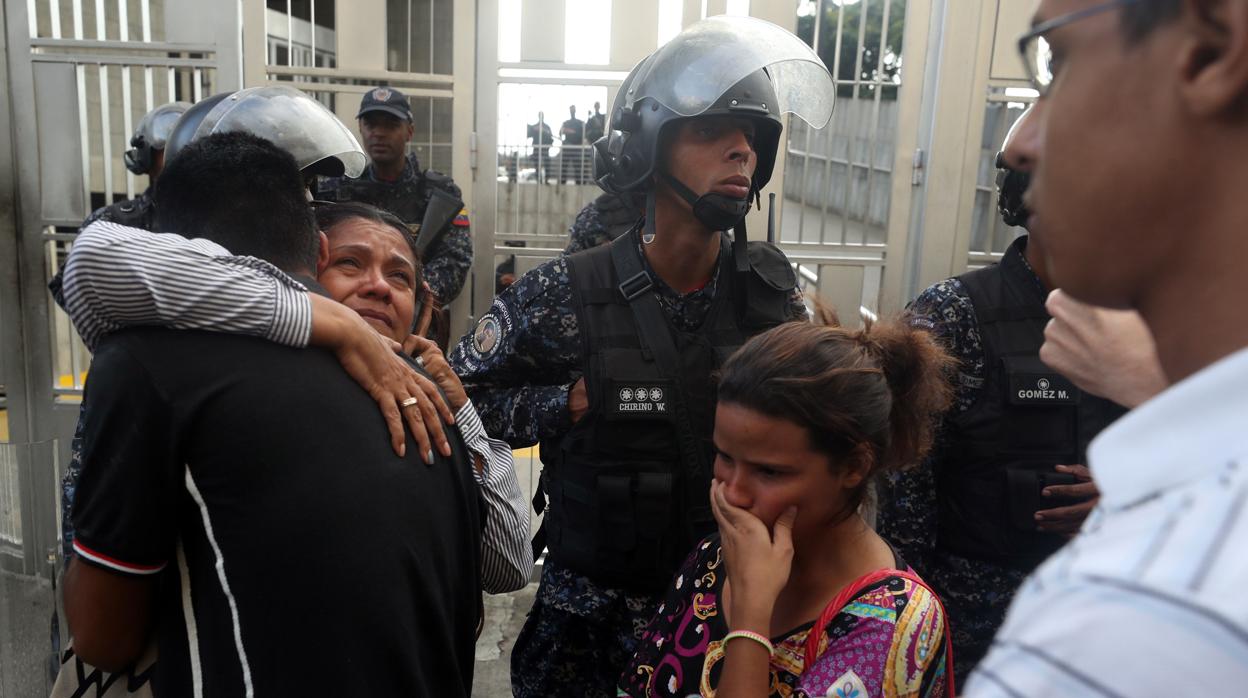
625,16,836,129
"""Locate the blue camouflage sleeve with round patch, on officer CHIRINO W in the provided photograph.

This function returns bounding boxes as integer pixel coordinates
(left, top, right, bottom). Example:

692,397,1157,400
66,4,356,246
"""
449,257,582,448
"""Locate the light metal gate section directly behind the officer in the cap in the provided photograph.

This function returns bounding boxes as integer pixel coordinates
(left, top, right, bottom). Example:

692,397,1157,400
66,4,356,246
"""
242,0,480,337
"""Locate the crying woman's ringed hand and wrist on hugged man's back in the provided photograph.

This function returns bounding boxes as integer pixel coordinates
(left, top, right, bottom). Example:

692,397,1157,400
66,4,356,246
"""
311,293,454,463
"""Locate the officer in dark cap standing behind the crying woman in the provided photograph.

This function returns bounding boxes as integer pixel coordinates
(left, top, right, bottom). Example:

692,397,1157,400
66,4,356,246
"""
314,87,472,303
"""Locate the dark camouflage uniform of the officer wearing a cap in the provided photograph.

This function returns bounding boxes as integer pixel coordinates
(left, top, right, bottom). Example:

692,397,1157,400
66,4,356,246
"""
313,154,472,303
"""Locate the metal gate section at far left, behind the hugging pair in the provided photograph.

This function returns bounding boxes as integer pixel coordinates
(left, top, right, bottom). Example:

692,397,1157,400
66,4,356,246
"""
0,0,241,696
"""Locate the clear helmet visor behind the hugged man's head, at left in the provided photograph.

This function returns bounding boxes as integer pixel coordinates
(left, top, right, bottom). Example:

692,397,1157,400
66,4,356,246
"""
195,85,368,177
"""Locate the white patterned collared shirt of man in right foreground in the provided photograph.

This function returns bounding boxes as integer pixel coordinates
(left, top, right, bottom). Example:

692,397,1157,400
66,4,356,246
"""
968,350,1248,698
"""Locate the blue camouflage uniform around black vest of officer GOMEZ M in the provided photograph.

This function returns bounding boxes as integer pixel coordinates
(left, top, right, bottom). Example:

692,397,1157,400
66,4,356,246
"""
876,249,1047,684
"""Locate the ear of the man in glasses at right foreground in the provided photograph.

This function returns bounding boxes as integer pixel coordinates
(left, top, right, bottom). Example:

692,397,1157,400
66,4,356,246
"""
1179,0,1248,116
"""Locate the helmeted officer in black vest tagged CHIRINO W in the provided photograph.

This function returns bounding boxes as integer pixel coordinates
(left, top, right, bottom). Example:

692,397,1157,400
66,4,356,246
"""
451,17,834,697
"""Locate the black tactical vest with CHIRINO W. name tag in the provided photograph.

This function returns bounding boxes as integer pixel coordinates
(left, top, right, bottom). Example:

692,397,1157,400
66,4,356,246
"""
542,232,796,592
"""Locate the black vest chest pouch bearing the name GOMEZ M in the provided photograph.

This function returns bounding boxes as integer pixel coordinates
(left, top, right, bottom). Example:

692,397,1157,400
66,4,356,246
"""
1001,356,1081,463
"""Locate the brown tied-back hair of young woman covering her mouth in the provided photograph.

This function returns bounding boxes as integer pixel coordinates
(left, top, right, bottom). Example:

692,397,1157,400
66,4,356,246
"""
719,313,953,511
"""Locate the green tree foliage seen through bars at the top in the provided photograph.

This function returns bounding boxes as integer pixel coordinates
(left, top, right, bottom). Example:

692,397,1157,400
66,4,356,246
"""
797,0,906,100
